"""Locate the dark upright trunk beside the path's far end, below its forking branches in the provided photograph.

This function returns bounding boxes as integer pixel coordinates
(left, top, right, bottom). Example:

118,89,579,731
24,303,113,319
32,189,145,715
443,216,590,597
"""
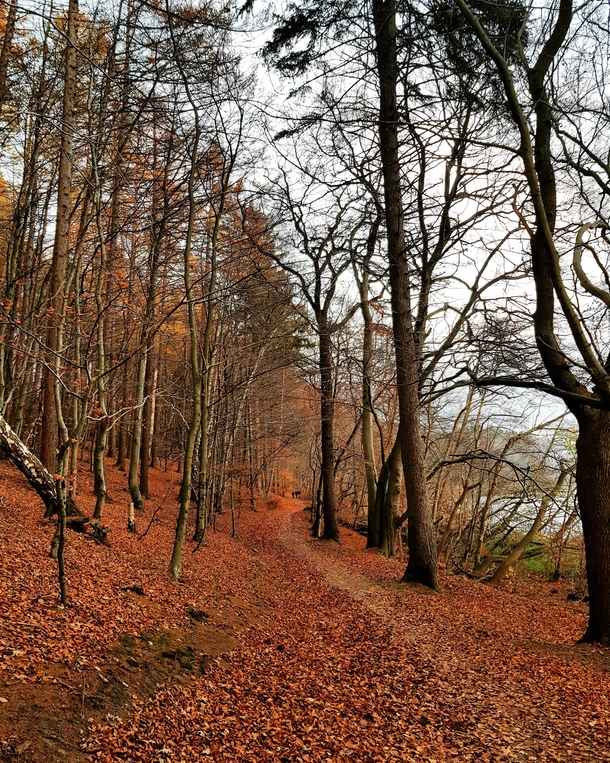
318,322,339,542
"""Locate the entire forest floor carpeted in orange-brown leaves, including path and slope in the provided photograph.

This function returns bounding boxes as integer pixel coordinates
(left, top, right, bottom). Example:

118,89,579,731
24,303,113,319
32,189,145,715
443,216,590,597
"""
0,462,610,763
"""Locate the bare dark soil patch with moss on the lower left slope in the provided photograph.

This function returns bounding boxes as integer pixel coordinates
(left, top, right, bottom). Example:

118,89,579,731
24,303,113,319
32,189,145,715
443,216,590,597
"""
0,596,263,763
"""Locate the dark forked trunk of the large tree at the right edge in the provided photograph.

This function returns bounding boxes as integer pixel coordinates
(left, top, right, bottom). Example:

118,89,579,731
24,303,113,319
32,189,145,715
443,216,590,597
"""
456,0,610,644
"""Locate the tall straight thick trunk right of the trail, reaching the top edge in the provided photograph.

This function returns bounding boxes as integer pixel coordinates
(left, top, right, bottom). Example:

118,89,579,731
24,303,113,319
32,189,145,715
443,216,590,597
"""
373,0,438,589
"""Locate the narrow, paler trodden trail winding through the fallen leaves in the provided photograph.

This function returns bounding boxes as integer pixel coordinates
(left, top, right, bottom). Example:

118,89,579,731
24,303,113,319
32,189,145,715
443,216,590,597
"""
280,504,610,761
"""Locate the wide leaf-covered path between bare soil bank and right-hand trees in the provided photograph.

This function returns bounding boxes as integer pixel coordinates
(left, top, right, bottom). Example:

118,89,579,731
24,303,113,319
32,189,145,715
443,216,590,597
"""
92,500,610,763
